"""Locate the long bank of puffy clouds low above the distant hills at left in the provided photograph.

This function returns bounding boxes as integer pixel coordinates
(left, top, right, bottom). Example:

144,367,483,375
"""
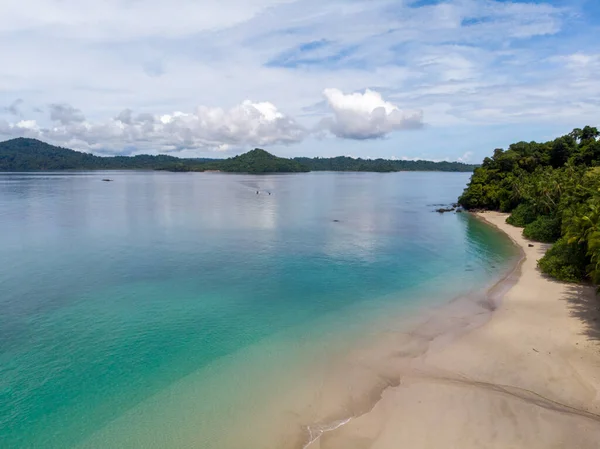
0,100,307,153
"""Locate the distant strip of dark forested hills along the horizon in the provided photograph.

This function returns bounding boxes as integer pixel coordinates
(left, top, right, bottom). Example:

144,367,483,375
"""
0,137,477,173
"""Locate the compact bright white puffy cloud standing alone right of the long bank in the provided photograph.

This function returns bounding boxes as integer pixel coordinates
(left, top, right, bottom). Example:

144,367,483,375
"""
320,88,423,140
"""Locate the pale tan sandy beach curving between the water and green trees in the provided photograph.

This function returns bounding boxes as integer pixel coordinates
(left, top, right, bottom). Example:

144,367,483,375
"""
310,212,600,449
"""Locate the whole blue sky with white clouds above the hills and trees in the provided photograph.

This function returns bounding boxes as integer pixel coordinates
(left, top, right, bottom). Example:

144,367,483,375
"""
0,0,600,163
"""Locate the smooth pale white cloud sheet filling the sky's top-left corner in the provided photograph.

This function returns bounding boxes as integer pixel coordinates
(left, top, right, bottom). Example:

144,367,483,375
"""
0,0,289,42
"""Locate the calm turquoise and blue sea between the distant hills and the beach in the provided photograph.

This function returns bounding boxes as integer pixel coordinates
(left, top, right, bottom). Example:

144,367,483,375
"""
0,172,514,449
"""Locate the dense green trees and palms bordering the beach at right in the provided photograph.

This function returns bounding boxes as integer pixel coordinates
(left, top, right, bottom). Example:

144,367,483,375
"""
459,126,600,284
